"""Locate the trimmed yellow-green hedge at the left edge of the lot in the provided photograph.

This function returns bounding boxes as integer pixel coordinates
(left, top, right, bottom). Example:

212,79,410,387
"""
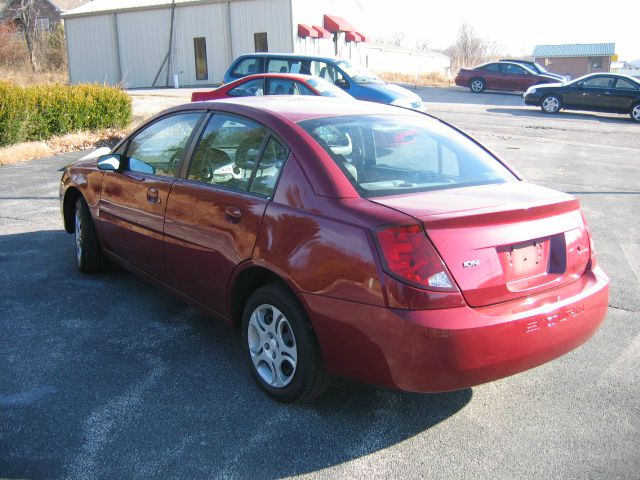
0,82,131,147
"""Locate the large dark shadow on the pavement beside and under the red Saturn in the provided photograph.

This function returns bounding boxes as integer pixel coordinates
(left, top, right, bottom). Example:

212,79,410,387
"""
0,230,472,479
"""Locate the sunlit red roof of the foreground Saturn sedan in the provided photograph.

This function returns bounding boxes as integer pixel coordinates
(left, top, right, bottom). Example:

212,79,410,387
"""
186,95,422,122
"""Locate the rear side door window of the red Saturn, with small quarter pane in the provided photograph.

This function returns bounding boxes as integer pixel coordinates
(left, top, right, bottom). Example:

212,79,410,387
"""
187,114,288,196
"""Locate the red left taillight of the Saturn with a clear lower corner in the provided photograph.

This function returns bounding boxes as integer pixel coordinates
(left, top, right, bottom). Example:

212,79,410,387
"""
374,225,458,291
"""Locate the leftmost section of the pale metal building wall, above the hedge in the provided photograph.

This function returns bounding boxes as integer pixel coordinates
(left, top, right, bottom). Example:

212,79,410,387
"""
64,15,120,85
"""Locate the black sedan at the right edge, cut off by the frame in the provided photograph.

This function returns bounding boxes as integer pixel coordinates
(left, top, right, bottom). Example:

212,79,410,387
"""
523,73,640,122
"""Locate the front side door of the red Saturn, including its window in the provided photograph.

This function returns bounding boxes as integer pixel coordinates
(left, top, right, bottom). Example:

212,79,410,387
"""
98,112,203,281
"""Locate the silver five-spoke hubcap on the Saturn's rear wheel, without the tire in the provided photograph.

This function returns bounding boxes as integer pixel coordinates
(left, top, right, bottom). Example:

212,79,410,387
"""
247,304,298,388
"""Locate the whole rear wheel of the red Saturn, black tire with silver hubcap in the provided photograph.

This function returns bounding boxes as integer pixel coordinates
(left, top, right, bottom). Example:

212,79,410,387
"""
242,283,331,403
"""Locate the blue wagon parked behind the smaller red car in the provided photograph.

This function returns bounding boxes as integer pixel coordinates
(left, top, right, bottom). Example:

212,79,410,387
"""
224,53,425,111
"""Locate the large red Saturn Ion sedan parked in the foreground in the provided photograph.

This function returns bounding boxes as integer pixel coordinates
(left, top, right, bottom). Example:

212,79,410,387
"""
60,96,608,402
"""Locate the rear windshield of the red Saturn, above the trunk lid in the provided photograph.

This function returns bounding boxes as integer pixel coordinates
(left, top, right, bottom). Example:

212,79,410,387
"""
300,115,518,197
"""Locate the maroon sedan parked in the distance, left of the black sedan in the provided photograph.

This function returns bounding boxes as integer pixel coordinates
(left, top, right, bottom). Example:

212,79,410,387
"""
455,62,558,93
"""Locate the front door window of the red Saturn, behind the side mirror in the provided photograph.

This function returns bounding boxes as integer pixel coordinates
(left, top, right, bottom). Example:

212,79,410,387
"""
126,113,201,177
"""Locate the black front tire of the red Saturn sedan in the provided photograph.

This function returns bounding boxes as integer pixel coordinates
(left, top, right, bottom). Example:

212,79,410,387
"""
74,197,107,273
